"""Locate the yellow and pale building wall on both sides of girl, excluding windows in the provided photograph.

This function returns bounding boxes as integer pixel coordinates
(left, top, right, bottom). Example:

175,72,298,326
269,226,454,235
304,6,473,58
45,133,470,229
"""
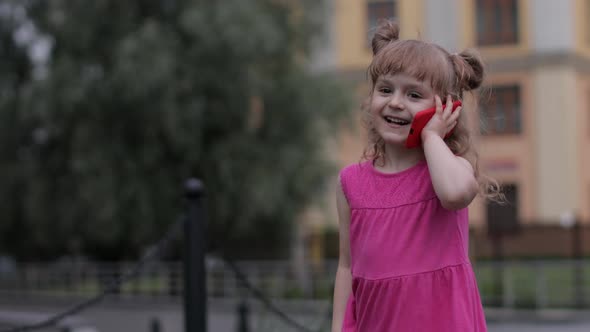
326,0,590,233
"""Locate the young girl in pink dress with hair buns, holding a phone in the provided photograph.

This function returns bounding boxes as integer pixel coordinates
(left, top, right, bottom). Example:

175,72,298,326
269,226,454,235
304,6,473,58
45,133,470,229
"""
332,22,498,332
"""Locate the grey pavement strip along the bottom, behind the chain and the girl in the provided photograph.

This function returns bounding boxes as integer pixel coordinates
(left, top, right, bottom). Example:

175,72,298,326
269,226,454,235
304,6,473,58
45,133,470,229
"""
0,295,590,332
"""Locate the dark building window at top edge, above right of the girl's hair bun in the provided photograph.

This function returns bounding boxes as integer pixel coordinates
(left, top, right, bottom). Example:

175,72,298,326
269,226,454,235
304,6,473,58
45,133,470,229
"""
476,0,518,46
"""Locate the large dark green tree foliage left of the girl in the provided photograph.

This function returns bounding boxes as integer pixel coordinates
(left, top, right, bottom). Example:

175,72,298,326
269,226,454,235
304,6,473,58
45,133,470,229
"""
0,0,349,259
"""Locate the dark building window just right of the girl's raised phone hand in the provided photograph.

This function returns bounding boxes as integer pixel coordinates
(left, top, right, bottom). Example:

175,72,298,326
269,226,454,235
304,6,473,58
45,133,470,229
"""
480,85,522,135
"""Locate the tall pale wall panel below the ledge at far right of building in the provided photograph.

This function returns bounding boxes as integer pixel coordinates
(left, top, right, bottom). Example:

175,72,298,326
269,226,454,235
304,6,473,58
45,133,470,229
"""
532,67,580,220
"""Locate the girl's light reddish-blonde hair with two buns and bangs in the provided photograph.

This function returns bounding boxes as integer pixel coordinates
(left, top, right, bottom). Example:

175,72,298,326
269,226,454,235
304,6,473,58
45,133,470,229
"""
363,21,503,202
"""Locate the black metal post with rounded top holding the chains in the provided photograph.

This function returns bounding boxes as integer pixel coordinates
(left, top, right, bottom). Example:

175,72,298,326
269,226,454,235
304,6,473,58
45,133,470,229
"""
184,179,207,332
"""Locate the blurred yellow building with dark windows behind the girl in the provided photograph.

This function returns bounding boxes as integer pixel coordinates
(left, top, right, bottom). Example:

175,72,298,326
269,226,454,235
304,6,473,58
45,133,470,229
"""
311,0,590,253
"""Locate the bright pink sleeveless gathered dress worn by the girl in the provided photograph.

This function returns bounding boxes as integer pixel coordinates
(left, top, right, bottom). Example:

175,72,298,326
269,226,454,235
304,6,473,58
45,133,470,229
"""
340,161,486,332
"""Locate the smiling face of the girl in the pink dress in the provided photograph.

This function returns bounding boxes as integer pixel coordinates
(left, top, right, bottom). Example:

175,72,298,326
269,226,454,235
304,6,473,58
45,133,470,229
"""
369,73,435,145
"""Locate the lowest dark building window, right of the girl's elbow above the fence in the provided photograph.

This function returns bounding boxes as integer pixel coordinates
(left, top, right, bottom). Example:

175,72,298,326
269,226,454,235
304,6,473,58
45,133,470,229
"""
486,184,519,235
